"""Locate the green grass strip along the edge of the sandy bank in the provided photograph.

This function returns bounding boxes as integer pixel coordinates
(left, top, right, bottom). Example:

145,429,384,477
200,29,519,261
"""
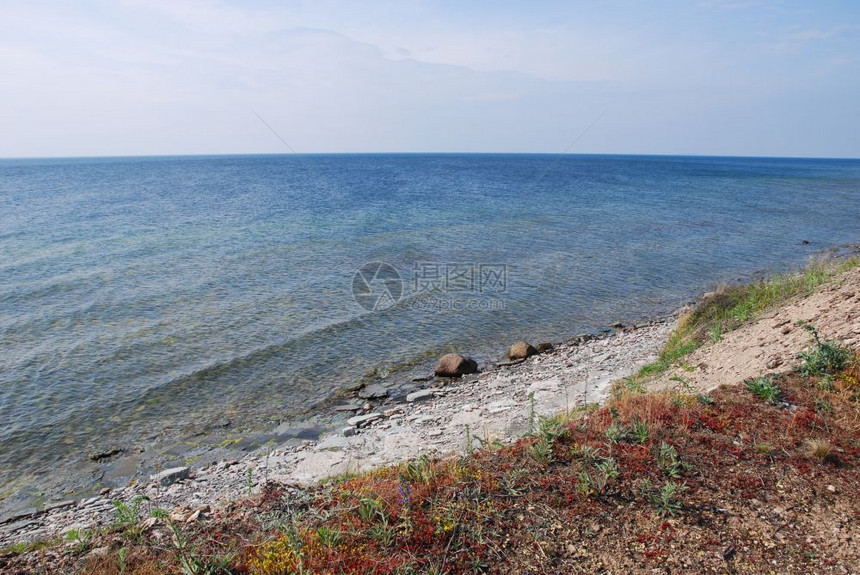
613,257,860,394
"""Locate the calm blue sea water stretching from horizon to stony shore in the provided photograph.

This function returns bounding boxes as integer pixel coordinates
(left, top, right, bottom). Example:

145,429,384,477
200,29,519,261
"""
0,155,860,508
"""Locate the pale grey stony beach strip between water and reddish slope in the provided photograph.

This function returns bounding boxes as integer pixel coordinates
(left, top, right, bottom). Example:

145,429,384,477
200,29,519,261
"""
0,320,677,546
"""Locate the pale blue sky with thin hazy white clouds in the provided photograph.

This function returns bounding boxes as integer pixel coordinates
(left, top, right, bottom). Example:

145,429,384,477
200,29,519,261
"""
0,0,860,158
